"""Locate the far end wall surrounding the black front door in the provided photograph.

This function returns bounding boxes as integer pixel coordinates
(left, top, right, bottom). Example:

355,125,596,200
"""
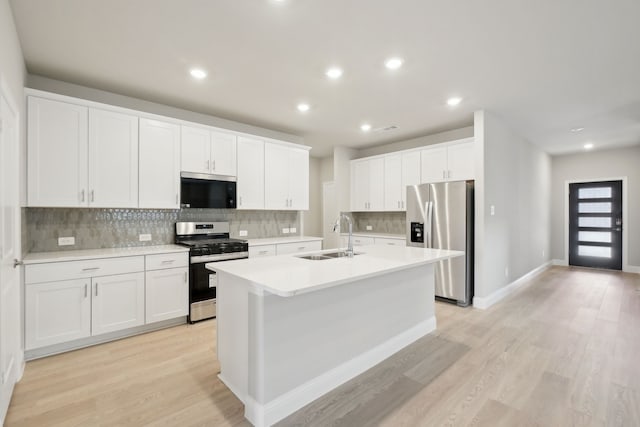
551,146,640,270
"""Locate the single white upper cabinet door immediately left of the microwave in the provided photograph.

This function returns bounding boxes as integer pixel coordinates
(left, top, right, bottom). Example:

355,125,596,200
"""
138,119,180,209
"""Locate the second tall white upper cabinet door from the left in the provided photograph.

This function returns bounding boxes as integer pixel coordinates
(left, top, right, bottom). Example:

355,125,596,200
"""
88,108,138,208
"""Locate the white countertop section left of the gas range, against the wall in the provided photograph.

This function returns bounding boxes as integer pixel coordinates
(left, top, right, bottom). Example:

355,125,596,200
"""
23,245,189,264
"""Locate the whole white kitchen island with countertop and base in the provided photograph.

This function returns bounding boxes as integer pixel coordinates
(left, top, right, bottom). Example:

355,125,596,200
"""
207,245,463,426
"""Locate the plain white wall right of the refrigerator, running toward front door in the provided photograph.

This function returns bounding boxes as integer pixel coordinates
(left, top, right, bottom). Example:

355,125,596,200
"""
474,111,551,304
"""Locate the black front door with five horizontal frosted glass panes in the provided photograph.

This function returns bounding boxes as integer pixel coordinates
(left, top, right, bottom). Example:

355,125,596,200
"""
569,181,622,270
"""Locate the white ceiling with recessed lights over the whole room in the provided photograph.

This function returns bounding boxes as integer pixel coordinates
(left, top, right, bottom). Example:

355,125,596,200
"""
11,0,640,155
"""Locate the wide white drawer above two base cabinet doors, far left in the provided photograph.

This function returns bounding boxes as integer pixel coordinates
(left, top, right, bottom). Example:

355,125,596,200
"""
24,256,144,284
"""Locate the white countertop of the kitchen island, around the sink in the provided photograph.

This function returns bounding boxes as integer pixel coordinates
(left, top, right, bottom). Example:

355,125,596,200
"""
206,245,464,297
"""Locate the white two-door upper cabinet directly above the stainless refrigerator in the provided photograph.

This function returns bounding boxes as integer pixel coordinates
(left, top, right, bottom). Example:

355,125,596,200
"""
421,138,475,182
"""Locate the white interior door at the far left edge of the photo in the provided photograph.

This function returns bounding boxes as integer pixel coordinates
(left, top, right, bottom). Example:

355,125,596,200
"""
0,91,22,424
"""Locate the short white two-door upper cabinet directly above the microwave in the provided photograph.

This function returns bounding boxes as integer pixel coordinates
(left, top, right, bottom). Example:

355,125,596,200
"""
181,126,236,176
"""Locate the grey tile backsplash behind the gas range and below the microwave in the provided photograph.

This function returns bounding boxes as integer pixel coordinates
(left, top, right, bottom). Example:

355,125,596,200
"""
22,208,300,252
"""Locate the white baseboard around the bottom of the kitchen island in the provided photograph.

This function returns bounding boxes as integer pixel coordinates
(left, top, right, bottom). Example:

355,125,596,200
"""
244,316,436,427
